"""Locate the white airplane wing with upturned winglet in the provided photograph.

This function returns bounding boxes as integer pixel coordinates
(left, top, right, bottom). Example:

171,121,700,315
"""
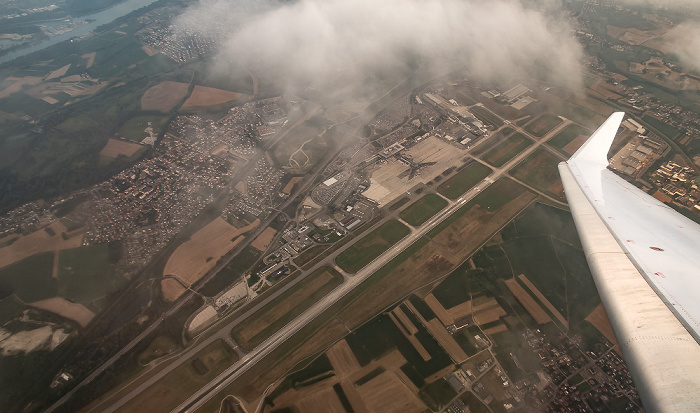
559,112,700,412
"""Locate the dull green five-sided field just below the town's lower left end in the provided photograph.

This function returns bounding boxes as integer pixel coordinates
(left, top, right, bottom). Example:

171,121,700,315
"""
58,244,127,313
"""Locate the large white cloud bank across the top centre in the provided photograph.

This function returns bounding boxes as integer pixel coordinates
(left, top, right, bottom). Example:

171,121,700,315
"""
180,0,581,96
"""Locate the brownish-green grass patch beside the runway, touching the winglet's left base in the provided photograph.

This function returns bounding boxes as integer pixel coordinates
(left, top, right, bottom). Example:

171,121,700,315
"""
510,148,566,201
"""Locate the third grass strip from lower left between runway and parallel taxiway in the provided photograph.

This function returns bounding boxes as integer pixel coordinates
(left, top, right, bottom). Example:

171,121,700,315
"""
335,220,410,274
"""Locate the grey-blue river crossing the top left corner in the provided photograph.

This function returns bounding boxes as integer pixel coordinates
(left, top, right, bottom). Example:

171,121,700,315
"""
0,0,158,64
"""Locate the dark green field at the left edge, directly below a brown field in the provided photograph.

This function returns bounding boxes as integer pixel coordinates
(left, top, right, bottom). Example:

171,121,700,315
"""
0,252,59,303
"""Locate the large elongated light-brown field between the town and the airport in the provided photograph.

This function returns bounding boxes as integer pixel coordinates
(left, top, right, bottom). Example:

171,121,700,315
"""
161,217,259,301
